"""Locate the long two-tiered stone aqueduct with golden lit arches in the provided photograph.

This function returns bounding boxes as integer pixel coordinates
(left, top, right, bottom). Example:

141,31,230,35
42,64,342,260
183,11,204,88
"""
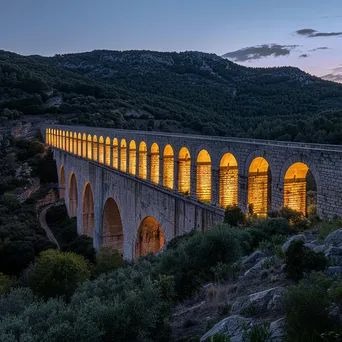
42,125,342,259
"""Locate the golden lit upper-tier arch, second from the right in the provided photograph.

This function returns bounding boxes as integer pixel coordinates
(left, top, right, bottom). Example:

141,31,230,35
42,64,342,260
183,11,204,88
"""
248,157,271,216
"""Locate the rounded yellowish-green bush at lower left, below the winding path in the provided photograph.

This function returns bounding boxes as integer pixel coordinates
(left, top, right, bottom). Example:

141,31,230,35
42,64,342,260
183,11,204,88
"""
28,249,90,298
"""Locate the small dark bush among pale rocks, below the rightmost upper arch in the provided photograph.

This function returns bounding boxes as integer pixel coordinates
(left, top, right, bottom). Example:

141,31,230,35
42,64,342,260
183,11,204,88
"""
285,240,327,280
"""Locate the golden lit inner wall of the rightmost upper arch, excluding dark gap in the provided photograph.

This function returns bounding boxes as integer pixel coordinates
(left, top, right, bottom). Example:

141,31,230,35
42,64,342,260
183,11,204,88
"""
284,163,309,215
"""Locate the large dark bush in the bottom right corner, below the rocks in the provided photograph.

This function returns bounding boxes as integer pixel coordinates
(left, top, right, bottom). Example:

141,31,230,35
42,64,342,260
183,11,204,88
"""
284,273,338,342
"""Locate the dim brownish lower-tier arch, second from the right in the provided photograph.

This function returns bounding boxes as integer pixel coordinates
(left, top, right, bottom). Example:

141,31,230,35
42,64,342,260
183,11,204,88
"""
102,197,124,255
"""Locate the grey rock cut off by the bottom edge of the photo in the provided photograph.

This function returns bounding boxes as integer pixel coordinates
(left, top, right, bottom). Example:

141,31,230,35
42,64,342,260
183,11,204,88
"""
200,315,251,342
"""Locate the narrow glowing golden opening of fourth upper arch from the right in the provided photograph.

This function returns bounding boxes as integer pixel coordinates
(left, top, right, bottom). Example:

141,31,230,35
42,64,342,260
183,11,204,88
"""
196,150,211,203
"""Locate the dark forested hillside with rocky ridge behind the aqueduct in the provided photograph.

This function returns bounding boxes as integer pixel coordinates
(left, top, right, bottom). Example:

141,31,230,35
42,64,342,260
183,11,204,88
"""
0,50,342,144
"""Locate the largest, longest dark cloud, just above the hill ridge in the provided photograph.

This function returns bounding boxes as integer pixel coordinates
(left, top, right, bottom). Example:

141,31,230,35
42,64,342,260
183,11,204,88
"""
222,44,298,62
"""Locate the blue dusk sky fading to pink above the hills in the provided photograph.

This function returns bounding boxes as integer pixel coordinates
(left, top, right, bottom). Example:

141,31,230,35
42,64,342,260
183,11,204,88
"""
0,0,342,82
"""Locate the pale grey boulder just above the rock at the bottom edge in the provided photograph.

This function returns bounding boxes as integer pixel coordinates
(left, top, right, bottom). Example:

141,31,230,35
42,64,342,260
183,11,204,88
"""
232,286,285,315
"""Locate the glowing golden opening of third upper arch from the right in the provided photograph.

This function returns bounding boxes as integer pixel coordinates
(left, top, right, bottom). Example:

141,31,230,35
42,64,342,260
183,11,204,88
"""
220,153,238,208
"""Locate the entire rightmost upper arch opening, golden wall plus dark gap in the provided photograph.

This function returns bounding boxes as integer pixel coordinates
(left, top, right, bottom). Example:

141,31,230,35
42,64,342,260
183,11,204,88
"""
284,162,317,215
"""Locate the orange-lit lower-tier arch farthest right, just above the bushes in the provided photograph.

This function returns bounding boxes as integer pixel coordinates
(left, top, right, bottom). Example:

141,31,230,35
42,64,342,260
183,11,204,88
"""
135,216,165,258
